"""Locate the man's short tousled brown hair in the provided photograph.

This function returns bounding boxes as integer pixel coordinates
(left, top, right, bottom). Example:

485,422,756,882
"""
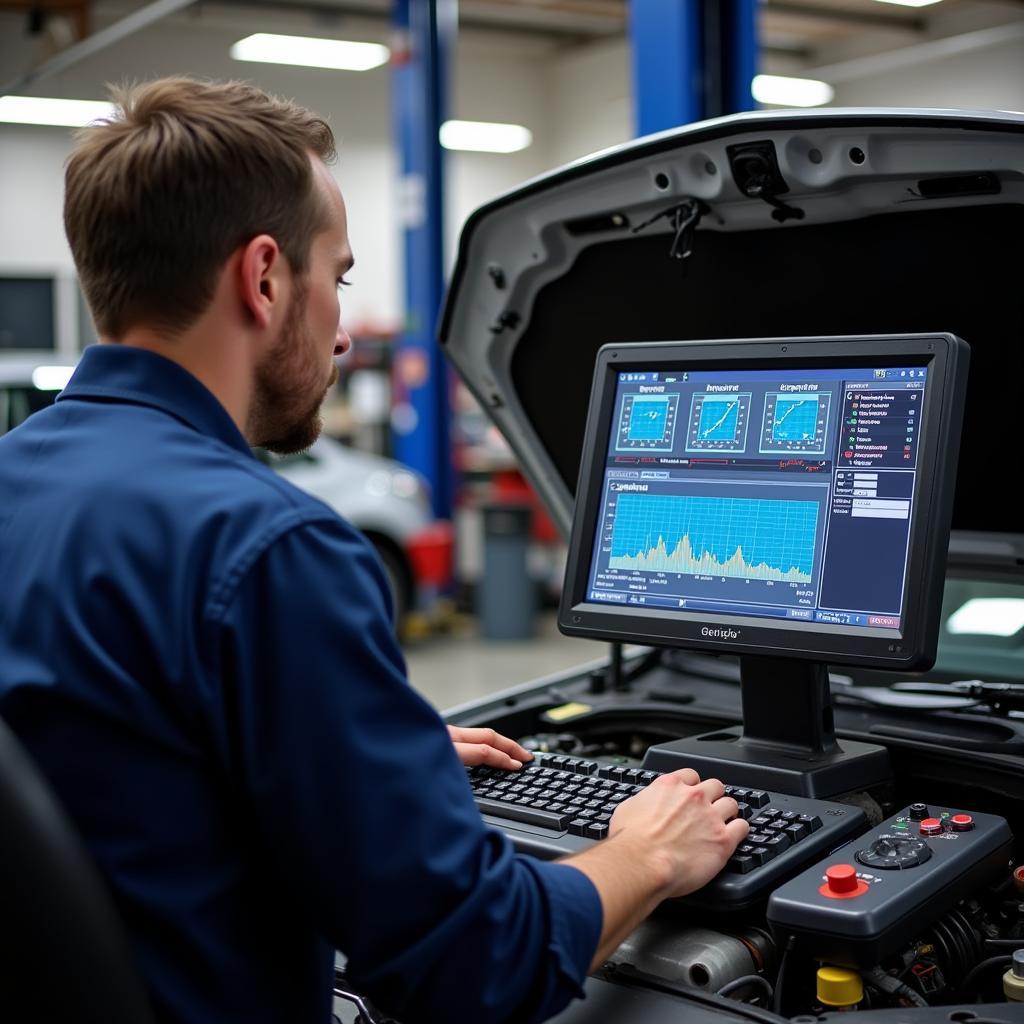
65,78,335,340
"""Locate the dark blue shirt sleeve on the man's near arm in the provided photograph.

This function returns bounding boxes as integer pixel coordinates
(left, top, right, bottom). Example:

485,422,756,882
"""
208,520,602,1024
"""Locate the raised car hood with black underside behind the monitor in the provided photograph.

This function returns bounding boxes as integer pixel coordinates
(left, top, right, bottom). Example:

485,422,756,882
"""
439,109,1024,551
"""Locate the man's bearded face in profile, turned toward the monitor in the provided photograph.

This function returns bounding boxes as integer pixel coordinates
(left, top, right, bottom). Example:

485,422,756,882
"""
251,159,352,455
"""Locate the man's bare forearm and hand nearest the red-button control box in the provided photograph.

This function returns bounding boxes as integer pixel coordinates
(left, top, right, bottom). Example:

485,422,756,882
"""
566,768,750,970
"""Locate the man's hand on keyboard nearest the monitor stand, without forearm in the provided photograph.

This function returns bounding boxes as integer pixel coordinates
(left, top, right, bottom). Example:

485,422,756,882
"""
608,768,750,896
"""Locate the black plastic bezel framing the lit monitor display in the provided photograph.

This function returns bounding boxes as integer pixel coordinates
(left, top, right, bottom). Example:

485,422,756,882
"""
558,333,969,670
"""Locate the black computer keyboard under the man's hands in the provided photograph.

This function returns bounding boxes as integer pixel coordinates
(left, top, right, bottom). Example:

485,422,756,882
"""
468,754,866,909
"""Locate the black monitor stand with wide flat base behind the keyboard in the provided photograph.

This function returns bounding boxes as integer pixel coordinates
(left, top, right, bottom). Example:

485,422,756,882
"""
643,655,892,799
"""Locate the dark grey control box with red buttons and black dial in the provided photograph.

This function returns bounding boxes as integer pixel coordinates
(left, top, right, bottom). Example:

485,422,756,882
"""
768,804,1013,967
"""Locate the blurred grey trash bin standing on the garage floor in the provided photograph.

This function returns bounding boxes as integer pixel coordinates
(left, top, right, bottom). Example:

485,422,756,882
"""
476,504,537,640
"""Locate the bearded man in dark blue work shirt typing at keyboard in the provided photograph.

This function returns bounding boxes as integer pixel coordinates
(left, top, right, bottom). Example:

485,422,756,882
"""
0,78,748,1024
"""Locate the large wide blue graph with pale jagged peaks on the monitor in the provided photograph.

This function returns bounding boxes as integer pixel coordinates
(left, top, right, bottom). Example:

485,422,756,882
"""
608,494,819,584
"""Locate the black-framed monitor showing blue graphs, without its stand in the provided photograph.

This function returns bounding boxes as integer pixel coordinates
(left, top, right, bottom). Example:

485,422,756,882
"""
560,335,967,667
